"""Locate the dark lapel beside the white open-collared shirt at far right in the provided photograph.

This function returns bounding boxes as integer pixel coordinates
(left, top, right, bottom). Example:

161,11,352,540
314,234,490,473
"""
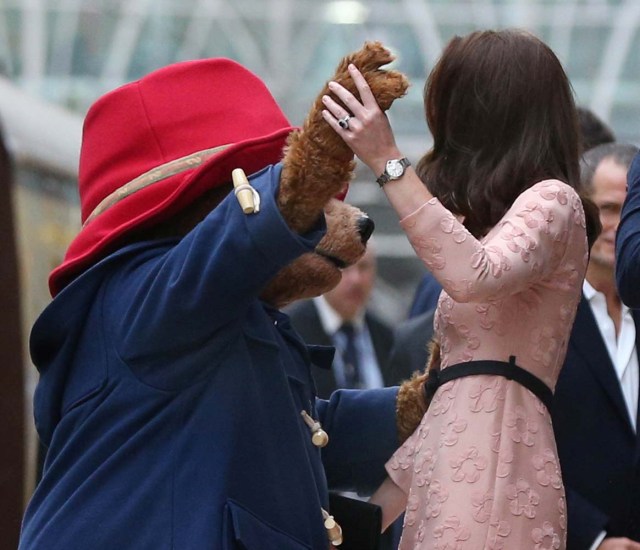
572,295,633,433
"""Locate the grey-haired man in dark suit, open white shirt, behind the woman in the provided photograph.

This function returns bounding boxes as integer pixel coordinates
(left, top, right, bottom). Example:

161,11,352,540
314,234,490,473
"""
552,143,640,550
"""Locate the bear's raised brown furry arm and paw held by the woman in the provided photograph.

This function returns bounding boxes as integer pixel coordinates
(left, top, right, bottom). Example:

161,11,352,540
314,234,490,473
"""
278,42,409,233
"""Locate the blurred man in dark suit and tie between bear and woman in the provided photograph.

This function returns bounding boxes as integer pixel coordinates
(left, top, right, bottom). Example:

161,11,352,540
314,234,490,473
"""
286,241,399,398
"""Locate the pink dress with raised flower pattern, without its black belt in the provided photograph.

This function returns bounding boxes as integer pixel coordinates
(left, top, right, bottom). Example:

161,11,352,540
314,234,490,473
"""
387,180,587,550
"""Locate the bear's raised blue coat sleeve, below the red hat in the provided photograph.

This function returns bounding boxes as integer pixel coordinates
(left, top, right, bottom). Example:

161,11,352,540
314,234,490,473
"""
109,166,326,357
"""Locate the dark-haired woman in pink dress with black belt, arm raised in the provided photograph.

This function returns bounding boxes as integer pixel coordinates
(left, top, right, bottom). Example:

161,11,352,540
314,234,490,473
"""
325,30,599,550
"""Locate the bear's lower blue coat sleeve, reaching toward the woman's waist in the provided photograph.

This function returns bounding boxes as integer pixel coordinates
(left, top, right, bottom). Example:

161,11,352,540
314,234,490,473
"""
316,387,398,495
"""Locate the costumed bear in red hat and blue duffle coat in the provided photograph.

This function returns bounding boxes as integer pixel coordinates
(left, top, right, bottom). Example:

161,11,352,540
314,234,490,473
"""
20,43,419,550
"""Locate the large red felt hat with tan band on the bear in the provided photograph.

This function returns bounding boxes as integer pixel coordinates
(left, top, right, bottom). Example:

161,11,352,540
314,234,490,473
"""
49,59,293,296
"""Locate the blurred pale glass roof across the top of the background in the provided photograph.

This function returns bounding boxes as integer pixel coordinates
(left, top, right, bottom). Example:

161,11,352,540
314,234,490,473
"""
0,0,640,151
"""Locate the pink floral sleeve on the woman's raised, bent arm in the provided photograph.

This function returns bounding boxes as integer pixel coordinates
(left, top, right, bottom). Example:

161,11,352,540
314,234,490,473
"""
400,180,586,302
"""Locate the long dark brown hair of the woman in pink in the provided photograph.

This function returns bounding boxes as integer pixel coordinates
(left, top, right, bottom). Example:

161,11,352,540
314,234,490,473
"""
417,30,597,245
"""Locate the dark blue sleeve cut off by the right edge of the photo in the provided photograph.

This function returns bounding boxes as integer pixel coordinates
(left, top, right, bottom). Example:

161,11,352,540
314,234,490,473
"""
616,154,640,308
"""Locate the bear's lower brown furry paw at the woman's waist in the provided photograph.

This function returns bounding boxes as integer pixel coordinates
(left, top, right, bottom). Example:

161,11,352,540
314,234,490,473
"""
396,339,440,444
